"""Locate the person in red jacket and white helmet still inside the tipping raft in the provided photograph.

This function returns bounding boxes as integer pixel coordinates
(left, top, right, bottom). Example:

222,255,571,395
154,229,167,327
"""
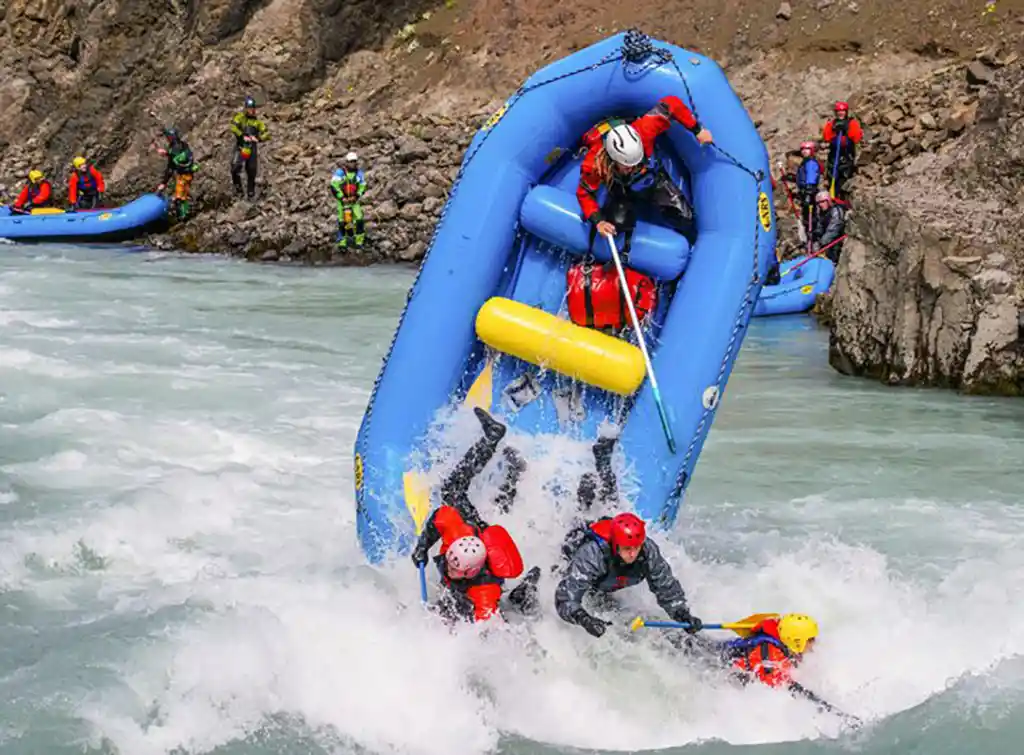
577,95,712,247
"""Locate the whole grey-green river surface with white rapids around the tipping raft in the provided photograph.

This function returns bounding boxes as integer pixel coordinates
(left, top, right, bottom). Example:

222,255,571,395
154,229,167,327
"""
0,245,1024,755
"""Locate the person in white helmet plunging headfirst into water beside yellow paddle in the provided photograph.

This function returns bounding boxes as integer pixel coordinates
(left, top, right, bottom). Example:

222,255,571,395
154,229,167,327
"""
412,409,541,622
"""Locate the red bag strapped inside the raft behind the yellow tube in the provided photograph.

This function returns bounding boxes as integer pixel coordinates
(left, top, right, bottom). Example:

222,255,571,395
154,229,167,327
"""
566,262,657,330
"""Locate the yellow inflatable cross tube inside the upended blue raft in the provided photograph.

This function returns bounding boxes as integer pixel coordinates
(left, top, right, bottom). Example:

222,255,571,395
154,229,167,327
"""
476,296,645,395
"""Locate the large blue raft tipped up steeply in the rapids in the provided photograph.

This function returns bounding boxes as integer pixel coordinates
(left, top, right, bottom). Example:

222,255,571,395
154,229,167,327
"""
354,32,775,562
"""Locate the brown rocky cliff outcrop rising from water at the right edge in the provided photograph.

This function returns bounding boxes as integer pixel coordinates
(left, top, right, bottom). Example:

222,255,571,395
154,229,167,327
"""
830,51,1024,395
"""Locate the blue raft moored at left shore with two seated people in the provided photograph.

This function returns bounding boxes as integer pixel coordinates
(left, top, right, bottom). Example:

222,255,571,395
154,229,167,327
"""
0,194,168,242
